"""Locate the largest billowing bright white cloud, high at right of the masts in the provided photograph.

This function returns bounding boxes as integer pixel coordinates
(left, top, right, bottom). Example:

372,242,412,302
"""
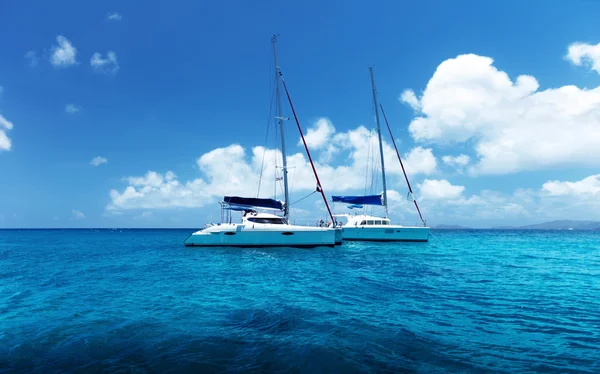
409,50,600,174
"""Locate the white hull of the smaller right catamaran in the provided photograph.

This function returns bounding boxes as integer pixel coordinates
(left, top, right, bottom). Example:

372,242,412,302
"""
343,226,429,242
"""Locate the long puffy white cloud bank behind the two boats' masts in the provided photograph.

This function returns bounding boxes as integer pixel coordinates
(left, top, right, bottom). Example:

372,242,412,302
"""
107,119,436,210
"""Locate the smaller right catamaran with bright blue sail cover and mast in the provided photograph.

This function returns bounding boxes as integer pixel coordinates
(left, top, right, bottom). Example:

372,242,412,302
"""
332,67,429,242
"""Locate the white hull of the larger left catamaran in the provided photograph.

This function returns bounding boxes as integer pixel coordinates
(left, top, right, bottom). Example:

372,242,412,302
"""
184,224,336,248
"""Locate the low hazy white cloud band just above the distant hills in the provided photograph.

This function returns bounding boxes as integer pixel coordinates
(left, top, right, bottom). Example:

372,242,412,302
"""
408,174,600,227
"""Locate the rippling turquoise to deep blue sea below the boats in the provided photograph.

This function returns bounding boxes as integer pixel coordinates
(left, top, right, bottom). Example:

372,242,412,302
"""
0,230,600,373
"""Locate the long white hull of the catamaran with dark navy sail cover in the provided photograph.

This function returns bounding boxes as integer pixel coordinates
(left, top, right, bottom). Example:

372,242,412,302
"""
184,229,336,248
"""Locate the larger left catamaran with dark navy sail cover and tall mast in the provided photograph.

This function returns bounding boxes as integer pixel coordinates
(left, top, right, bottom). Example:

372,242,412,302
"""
184,35,342,248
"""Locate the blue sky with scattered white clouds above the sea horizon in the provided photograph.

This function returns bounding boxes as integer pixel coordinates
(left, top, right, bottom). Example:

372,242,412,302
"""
0,1,600,227
